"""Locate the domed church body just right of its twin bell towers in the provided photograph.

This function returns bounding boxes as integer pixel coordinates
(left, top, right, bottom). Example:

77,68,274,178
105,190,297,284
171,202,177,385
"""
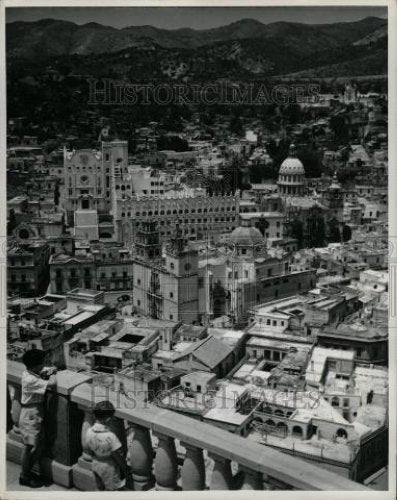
198,225,316,324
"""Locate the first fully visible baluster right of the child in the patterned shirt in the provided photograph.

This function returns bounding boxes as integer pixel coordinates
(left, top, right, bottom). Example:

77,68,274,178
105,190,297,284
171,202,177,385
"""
129,423,154,491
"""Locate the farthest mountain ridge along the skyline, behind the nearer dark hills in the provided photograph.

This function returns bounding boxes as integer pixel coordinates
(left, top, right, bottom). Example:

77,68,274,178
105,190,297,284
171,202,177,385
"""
6,17,387,58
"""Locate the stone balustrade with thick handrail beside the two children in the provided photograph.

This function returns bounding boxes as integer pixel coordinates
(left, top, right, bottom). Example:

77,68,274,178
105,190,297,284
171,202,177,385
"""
7,361,370,491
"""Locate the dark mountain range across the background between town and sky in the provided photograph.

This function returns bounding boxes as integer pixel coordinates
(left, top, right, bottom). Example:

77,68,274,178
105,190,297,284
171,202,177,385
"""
6,17,387,79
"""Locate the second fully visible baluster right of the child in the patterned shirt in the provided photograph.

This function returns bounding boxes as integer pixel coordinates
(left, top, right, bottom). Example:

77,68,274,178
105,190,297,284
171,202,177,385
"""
154,434,178,491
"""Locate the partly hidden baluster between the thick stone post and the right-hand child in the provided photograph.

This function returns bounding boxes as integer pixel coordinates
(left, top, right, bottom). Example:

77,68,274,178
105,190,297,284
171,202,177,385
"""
73,406,97,491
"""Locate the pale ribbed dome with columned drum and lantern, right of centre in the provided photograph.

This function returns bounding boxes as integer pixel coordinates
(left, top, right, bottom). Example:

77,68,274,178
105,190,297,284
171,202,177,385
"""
277,144,305,196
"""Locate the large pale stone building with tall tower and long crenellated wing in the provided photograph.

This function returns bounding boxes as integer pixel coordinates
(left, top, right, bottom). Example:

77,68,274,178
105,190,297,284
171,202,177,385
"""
62,141,239,243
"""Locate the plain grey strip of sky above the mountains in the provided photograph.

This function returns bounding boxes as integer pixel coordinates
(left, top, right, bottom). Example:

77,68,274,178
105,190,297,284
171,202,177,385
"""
6,7,387,29
